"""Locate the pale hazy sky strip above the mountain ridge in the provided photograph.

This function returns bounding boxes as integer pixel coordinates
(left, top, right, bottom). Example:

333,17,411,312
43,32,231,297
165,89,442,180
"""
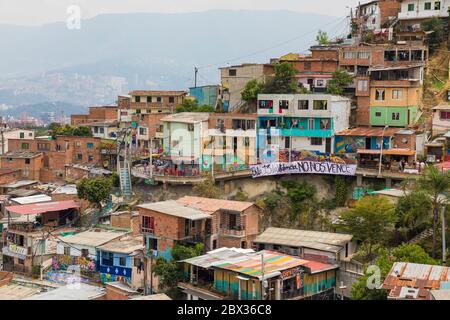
0,0,358,25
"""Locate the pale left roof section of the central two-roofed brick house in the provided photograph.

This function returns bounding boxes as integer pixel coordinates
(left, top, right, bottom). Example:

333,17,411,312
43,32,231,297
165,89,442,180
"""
138,200,211,220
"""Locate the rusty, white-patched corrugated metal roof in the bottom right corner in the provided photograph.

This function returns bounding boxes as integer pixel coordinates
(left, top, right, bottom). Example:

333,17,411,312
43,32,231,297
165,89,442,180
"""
382,262,450,299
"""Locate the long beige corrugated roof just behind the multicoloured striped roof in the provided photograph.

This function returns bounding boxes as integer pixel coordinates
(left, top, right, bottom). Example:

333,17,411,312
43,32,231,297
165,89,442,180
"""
254,228,353,252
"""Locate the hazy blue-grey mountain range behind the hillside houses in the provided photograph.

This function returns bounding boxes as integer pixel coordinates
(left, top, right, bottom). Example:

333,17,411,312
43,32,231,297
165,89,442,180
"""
0,10,338,119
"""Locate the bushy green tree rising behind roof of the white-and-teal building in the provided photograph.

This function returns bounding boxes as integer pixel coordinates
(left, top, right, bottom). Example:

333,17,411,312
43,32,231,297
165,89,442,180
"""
263,62,298,94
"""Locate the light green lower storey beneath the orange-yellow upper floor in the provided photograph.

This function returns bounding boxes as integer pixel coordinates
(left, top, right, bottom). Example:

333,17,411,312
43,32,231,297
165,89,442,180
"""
370,106,417,127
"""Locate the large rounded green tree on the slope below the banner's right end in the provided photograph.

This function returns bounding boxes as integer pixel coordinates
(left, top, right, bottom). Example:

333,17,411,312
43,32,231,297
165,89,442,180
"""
339,196,396,259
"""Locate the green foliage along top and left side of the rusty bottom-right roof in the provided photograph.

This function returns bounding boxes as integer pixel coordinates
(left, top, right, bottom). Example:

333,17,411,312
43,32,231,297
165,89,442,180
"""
351,244,438,300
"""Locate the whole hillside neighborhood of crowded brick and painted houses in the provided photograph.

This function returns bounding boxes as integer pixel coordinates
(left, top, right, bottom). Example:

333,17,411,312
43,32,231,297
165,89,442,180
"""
0,0,450,301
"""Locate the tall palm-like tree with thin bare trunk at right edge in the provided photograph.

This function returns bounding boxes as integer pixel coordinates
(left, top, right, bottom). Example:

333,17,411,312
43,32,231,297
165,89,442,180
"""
418,166,450,258
